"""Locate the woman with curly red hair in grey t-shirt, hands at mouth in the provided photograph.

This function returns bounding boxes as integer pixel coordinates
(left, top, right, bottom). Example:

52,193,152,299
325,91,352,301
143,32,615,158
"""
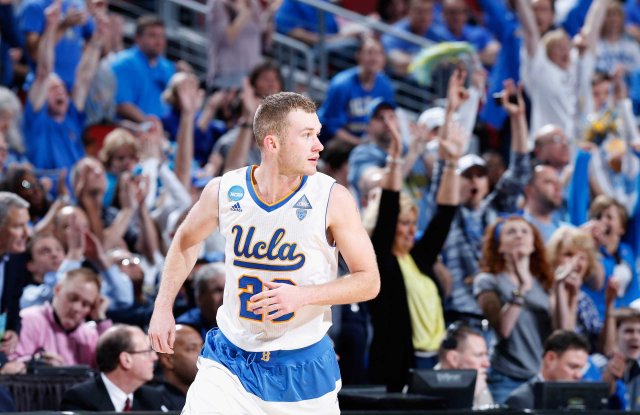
473,216,553,403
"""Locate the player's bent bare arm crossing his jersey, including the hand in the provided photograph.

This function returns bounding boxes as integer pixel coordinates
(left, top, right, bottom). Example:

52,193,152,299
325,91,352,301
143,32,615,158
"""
249,184,380,320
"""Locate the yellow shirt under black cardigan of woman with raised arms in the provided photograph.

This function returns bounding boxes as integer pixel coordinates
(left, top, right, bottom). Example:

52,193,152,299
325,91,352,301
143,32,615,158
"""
397,255,446,352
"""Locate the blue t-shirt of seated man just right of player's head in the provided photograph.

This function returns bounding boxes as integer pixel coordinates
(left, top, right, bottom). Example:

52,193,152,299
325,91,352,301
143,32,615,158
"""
318,67,395,139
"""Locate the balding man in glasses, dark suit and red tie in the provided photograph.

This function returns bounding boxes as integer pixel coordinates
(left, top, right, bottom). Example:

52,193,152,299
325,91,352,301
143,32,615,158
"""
60,325,168,412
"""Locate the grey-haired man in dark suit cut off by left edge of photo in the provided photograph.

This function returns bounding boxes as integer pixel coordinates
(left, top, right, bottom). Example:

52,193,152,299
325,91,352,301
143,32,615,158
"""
0,192,29,365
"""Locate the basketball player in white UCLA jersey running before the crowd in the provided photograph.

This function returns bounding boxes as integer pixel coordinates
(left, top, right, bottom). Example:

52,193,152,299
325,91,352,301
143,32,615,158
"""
149,92,380,415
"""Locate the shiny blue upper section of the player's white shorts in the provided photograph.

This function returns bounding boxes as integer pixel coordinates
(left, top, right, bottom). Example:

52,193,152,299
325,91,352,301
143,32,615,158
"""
200,328,340,402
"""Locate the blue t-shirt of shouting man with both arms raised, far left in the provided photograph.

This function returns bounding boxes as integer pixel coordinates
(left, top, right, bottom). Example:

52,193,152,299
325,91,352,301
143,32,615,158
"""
23,101,85,169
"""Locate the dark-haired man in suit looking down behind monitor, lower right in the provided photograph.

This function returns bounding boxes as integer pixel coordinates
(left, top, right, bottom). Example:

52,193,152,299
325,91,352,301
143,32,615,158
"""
505,330,589,409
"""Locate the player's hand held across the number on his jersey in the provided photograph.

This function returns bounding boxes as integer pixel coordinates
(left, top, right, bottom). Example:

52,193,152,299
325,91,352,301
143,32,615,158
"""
247,282,305,321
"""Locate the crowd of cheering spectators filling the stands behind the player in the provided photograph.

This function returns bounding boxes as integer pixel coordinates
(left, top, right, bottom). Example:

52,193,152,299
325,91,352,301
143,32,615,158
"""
0,0,640,411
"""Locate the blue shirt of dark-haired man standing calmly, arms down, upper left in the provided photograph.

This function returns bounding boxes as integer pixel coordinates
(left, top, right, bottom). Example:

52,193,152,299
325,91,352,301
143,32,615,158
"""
111,46,176,118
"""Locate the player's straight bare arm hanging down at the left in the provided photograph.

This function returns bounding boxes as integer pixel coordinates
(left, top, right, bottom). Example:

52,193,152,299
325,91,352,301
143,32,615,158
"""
149,178,220,353
